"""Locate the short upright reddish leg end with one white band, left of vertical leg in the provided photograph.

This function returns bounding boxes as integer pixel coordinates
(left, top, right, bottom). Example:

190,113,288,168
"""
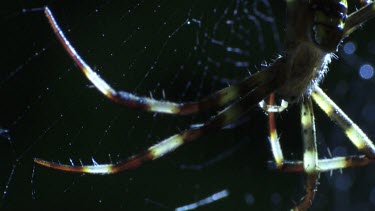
268,93,284,169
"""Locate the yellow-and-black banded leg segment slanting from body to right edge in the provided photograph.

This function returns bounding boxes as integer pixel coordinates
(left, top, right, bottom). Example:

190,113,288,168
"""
312,87,375,159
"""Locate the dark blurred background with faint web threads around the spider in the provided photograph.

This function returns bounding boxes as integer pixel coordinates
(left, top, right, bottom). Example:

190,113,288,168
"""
0,0,375,210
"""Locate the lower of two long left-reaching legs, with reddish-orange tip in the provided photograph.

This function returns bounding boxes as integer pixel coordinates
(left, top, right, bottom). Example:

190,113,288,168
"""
34,65,284,174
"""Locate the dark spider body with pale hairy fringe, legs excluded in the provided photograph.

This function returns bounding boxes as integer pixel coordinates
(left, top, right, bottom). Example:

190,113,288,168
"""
277,0,347,103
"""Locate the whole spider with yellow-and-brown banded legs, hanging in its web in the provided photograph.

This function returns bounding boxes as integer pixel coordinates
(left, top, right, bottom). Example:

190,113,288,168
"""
34,0,375,210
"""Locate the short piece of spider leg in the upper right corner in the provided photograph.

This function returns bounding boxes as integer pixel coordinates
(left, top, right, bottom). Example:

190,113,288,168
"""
344,1,375,36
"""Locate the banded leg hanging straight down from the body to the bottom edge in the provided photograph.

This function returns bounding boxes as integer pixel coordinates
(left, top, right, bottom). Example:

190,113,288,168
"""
294,98,319,210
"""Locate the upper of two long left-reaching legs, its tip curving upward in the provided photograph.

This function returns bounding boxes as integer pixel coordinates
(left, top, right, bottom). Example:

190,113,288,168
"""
44,7,270,115
